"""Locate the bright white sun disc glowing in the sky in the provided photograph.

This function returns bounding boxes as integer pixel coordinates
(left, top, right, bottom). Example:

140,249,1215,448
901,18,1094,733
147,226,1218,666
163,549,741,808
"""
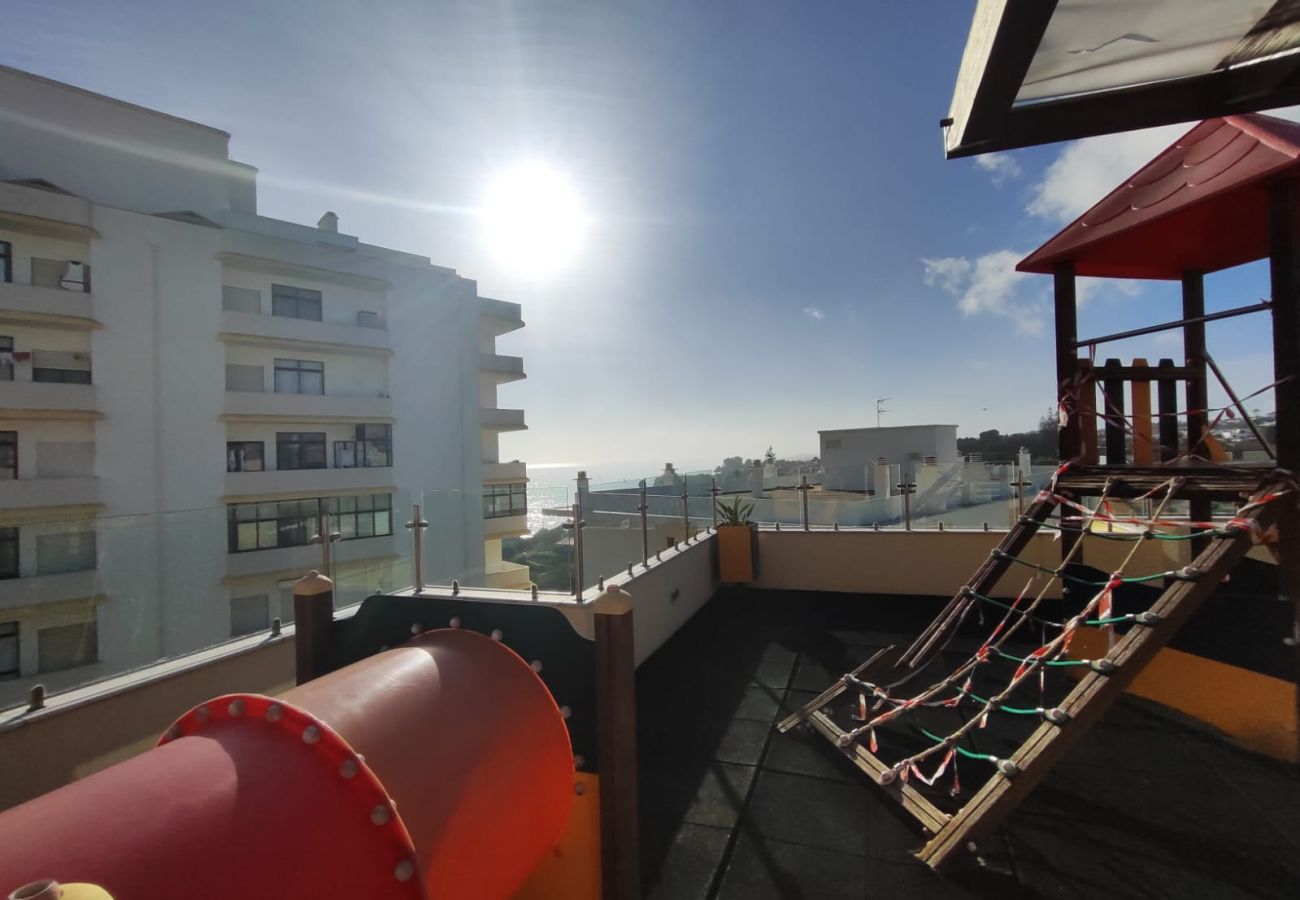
481,163,586,276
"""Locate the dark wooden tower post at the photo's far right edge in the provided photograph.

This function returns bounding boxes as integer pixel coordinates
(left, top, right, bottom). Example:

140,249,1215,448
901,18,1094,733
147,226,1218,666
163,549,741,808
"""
1269,181,1300,754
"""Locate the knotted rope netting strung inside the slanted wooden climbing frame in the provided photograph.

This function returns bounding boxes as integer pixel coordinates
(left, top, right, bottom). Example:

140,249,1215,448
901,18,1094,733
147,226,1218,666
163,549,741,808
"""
828,467,1282,797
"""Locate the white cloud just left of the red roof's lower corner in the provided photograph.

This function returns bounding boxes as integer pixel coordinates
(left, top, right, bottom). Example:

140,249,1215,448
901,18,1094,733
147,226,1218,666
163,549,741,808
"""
920,250,1045,334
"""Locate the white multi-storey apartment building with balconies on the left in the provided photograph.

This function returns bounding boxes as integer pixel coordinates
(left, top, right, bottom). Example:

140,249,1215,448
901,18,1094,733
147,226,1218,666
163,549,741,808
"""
0,66,529,705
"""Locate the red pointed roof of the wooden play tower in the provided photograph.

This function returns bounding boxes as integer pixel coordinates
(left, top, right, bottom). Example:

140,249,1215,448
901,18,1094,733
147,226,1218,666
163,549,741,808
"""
1015,114,1300,278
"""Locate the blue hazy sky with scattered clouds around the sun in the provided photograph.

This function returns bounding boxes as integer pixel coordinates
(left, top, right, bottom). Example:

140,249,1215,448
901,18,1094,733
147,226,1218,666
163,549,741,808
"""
0,0,1271,477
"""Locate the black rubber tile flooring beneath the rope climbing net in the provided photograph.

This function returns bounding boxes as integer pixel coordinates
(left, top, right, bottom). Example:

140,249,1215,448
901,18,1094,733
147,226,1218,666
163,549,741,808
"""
637,590,1300,900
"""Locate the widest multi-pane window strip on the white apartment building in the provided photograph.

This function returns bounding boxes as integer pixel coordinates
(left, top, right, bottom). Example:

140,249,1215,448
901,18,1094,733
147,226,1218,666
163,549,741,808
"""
228,494,393,553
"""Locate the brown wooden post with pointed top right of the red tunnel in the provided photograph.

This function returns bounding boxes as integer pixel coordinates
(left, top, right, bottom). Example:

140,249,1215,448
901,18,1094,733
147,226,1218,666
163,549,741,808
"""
592,587,641,900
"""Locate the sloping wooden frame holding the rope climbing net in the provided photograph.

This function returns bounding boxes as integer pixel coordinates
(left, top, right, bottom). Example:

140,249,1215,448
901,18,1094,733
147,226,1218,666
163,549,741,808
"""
777,473,1286,869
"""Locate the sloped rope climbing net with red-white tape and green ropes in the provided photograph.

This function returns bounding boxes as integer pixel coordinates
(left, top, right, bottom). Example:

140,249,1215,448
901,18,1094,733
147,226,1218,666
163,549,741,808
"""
839,467,1290,797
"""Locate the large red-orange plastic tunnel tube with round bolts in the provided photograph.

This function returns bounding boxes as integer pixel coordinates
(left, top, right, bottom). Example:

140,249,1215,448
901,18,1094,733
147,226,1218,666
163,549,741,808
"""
0,629,573,900
